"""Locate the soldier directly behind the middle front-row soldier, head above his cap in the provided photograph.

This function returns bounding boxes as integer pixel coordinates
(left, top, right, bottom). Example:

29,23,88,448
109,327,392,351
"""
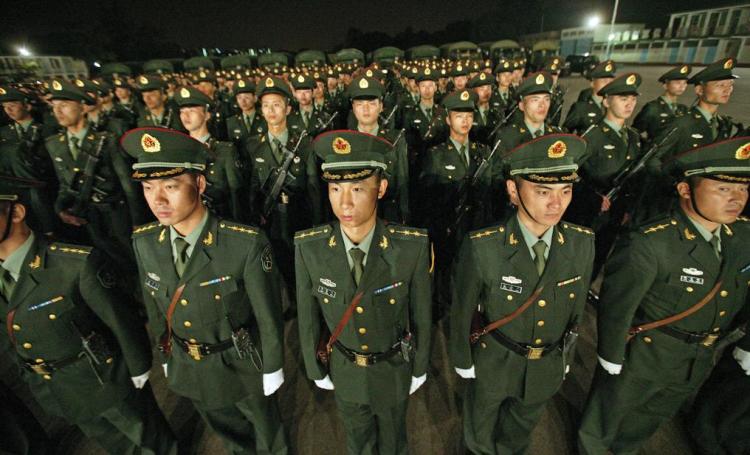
347,76,411,224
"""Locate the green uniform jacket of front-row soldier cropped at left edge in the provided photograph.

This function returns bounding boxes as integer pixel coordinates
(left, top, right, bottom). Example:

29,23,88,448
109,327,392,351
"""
0,240,151,422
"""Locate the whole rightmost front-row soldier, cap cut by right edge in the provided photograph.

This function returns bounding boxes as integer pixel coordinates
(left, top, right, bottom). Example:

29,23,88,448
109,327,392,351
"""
579,137,750,454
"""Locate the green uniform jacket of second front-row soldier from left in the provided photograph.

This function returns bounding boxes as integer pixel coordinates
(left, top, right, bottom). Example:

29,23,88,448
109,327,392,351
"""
133,214,283,408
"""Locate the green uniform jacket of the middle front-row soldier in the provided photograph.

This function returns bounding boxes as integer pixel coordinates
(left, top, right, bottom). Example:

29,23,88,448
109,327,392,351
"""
295,220,432,406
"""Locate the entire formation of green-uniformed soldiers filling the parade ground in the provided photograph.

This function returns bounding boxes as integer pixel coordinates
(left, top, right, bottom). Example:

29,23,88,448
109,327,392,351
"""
0,48,750,454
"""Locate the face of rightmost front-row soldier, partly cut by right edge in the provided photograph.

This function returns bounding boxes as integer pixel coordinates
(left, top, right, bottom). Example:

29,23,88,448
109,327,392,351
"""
677,178,748,224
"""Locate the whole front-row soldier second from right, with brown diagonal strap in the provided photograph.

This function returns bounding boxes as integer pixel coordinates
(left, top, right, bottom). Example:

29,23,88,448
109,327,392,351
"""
450,134,594,454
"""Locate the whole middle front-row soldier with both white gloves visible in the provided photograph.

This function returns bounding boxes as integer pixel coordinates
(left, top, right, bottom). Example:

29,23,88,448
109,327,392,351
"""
295,131,432,454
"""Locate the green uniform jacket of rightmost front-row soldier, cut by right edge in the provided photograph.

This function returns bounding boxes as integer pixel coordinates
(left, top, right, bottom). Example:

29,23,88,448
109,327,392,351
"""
598,209,750,385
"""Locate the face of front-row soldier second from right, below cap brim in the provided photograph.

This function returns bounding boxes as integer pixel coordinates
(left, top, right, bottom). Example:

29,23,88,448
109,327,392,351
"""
506,179,573,232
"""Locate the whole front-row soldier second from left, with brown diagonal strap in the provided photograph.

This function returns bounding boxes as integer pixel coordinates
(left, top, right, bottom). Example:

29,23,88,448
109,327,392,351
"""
123,128,288,454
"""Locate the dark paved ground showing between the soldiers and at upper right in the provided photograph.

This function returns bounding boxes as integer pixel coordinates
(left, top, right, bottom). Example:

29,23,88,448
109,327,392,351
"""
0,67,750,455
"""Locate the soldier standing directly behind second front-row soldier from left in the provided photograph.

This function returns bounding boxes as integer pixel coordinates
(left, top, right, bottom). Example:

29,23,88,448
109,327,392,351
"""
175,87,251,222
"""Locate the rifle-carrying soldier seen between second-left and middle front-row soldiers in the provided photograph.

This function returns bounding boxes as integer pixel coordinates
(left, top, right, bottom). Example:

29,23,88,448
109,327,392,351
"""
245,76,323,300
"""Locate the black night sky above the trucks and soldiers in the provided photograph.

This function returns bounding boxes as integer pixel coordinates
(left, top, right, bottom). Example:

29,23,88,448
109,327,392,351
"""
0,0,731,60
